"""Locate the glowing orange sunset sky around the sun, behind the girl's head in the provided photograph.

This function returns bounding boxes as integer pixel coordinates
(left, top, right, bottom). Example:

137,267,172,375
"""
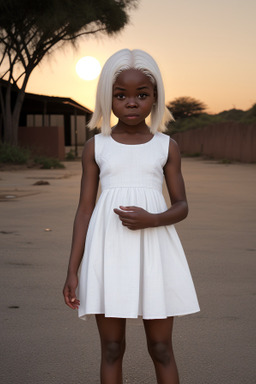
27,0,256,113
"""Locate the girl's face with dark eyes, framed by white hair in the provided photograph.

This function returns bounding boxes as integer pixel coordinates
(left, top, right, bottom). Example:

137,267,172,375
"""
112,69,155,126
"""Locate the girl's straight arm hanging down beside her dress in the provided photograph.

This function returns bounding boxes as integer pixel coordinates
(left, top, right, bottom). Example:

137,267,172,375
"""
63,138,99,309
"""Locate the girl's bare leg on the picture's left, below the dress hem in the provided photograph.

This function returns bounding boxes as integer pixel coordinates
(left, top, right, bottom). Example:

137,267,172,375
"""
96,315,126,384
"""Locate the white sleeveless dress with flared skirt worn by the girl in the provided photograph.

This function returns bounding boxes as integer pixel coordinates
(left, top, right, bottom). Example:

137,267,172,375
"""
78,133,199,319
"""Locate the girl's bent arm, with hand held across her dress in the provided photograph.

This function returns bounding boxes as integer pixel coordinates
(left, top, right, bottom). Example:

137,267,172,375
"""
114,139,188,230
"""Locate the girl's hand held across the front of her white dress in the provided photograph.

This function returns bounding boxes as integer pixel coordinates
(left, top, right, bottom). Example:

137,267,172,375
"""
114,206,156,230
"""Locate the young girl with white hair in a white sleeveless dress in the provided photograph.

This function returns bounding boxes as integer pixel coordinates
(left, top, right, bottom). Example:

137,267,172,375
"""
63,49,199,384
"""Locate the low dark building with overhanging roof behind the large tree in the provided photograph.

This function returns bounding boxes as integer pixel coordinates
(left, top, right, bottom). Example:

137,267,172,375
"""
0,80,94,157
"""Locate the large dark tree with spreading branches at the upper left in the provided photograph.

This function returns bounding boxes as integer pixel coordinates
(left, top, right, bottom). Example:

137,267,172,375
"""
0,0,137,144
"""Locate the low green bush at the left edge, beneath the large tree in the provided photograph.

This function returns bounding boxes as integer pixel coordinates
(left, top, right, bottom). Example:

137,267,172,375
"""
0,143,31,164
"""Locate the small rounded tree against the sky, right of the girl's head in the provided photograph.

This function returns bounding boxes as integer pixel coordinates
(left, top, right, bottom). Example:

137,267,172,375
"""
167,96,207,119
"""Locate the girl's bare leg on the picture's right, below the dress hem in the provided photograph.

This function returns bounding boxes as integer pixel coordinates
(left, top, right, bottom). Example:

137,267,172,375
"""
144,317,179,384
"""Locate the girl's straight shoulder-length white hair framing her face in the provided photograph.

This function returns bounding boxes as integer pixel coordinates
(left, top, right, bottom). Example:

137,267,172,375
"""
88,49,173,135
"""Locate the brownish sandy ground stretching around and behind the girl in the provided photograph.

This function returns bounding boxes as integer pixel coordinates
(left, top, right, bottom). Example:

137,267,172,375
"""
0,159,256,384
